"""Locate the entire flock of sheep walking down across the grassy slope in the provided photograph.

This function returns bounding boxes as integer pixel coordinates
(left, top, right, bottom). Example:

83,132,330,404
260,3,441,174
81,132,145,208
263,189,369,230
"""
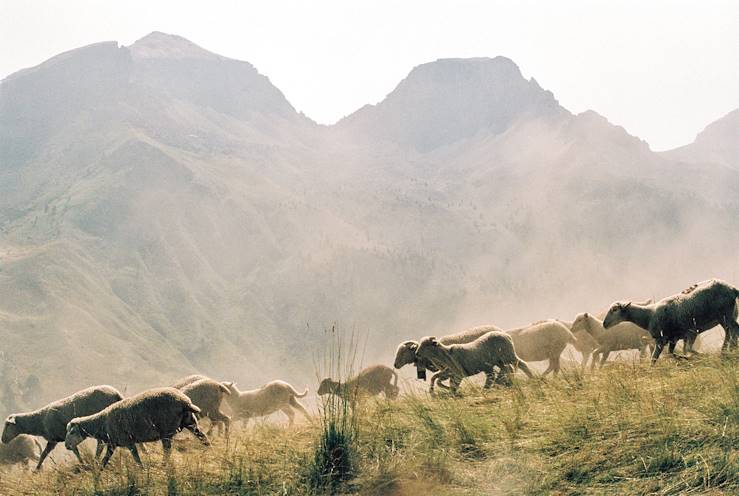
0,279,739,469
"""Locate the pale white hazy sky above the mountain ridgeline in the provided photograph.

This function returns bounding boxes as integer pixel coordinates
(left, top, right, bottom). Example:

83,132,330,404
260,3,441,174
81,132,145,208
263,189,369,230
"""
0,0,739,150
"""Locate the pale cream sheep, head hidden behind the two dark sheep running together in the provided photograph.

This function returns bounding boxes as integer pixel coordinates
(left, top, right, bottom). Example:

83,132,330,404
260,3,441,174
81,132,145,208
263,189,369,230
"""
505,320,577,375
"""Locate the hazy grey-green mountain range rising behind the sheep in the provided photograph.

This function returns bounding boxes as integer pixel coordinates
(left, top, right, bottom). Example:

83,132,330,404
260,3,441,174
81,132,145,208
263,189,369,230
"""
0,33,739,400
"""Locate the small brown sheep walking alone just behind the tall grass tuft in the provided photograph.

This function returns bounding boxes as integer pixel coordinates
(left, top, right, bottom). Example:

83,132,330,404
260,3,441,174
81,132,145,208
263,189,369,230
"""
318,365,400,404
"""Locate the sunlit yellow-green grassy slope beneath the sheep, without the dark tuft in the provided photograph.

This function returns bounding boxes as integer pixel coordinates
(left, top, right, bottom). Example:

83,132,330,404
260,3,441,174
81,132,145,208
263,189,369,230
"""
0,357,739,495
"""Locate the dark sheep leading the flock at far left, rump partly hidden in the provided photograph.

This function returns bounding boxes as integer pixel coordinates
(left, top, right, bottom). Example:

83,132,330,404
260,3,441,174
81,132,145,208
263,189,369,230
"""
2,386,123,470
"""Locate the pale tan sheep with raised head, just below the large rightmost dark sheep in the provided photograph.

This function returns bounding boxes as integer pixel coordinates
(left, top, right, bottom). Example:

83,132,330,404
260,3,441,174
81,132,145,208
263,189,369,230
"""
572,312,654,370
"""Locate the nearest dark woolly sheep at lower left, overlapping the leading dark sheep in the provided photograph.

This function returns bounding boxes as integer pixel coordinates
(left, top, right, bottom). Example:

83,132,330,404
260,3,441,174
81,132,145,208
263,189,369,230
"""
64,387,210,467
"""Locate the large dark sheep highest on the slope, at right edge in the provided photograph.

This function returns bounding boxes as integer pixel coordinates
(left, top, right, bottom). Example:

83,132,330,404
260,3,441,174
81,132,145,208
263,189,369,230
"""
603,279,739,363
